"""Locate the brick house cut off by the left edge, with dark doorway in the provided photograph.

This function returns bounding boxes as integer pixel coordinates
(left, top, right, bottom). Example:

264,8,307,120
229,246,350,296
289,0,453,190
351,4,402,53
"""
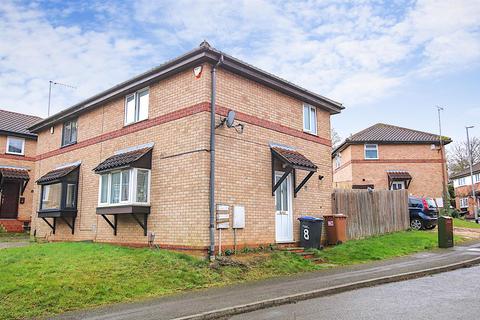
0,110,41,232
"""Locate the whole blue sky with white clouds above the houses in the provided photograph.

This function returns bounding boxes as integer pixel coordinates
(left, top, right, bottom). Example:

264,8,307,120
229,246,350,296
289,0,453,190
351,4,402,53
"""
0,0,480,145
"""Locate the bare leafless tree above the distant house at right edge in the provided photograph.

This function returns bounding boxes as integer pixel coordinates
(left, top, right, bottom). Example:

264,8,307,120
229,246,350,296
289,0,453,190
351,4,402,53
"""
447,137,480,175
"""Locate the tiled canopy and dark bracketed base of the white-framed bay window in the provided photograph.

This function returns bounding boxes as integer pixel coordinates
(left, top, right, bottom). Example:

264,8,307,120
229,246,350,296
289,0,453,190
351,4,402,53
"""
93,143,153,235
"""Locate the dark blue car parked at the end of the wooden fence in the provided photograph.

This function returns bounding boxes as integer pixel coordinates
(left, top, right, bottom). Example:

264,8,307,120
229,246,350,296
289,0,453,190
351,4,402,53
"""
408,196,438,230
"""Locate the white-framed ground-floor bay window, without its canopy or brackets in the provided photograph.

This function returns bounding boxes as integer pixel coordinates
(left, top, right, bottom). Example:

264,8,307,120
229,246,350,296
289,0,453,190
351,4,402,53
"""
98,168,152,207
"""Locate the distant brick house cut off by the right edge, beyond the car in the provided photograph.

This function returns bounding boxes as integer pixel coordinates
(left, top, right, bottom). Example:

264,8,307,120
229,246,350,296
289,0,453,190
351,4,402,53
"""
450,163,480,218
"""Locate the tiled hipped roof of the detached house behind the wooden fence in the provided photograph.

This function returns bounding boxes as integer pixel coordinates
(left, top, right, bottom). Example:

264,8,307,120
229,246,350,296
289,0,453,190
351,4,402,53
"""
332,123,452,154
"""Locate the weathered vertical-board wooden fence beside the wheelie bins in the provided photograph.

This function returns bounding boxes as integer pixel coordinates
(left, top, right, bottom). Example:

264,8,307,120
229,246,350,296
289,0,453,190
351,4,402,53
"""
332,189,410,239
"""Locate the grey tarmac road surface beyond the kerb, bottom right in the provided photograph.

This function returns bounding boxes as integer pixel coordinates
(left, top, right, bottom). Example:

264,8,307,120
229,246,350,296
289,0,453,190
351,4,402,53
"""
230,267,480,320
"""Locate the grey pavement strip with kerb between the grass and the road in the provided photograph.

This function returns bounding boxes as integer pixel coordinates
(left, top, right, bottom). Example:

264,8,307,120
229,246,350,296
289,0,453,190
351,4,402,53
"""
55,243,480,320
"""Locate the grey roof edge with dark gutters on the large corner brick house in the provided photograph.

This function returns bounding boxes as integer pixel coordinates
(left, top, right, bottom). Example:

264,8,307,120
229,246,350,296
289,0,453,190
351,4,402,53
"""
30,41,344,132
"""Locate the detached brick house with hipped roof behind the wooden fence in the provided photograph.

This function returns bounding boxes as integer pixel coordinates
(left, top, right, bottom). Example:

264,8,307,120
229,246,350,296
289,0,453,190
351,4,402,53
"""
332,123,451,198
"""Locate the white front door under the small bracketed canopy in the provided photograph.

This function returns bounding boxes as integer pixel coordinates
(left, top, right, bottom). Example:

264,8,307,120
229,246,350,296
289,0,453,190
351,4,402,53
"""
275,172,293,242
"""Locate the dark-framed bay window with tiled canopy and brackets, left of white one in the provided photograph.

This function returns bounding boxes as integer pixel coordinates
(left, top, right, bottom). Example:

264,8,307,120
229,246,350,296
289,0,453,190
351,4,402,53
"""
37,161,81,234
